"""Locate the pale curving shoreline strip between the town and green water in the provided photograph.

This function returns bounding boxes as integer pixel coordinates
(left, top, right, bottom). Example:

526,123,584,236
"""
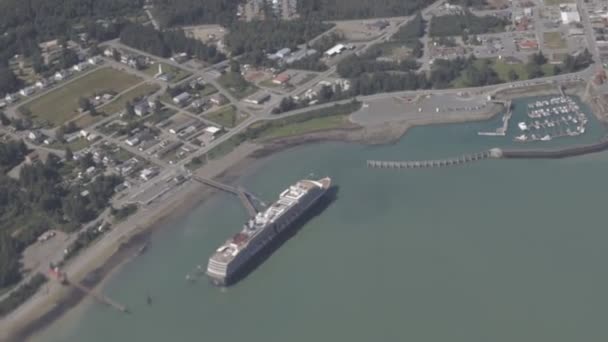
0,87,605,341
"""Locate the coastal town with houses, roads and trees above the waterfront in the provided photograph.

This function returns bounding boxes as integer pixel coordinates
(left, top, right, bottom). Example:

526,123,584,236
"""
0,0,608,341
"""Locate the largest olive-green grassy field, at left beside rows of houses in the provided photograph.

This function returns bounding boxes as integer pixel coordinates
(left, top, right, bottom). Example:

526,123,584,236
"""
23,68,141,126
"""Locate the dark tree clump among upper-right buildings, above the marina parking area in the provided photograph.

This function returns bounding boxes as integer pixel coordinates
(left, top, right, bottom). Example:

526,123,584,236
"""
429,11,509,37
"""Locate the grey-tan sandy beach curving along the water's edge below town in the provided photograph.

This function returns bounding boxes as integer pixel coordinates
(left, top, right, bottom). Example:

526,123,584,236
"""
0,81,604,341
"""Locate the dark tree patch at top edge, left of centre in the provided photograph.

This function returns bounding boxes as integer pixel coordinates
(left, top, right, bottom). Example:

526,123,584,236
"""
152,0,243,27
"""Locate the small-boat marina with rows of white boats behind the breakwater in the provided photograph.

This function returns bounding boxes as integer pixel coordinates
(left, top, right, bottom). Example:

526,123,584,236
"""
514,95,588,142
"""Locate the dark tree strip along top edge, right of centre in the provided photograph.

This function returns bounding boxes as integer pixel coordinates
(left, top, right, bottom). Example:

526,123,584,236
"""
298,0,432,20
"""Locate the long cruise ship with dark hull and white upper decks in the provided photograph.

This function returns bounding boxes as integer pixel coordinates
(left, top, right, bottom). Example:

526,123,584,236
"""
207,177,331,286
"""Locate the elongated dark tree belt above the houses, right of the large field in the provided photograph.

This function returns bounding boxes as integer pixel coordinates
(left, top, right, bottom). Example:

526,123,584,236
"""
120,24,226,63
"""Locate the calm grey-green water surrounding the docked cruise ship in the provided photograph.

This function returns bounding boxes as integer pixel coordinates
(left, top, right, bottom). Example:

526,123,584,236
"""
35,97,608,342
